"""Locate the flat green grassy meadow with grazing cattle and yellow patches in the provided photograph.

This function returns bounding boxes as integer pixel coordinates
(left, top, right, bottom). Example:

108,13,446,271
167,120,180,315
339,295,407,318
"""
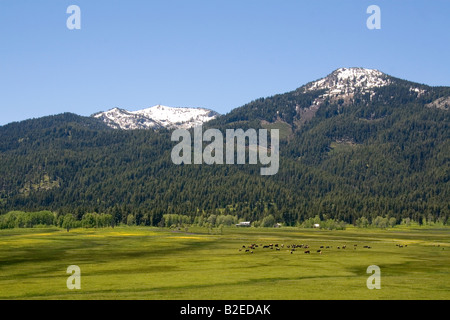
0,227,450,300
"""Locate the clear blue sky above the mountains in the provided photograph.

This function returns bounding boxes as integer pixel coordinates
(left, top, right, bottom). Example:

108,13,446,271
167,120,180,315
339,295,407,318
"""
0,0,450,125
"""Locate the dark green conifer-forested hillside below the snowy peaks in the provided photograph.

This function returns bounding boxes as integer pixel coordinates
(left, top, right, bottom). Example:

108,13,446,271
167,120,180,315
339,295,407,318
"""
0,69,450,225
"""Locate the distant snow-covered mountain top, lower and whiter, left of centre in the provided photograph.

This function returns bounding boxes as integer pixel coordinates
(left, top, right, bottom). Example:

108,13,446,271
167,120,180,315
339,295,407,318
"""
92,105,219,130
